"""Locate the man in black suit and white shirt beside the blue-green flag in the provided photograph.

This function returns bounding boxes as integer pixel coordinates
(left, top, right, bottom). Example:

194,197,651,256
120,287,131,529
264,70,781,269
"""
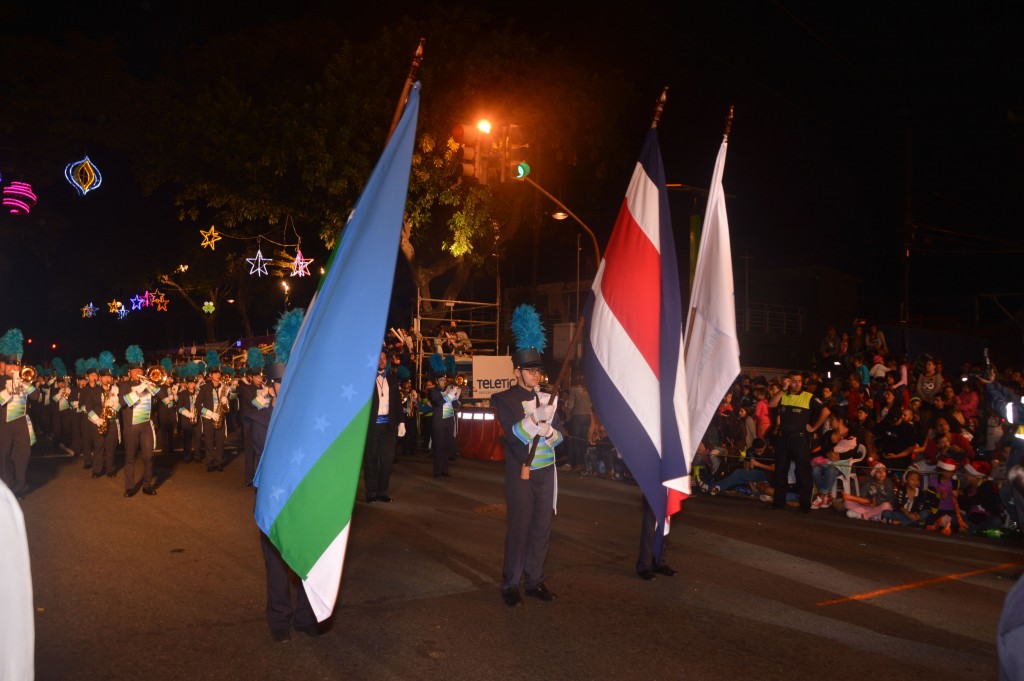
362,352,406,504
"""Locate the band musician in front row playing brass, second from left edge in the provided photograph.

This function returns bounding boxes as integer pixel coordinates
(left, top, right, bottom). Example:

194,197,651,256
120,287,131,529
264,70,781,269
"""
118,345,160,498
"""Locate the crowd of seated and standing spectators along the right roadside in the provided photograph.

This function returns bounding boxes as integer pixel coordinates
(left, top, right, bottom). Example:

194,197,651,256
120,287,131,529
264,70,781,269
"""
693,323,1024,537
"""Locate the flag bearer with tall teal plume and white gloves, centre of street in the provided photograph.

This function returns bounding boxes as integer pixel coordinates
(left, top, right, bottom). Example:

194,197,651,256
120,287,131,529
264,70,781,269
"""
490,305,562,607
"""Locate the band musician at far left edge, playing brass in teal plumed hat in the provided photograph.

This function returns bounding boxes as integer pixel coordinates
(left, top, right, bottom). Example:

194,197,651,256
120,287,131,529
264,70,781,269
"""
0,329,36,499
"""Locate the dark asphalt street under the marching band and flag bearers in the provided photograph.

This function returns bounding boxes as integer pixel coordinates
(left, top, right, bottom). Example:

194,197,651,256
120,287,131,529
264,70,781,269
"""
22,436,1024,681
